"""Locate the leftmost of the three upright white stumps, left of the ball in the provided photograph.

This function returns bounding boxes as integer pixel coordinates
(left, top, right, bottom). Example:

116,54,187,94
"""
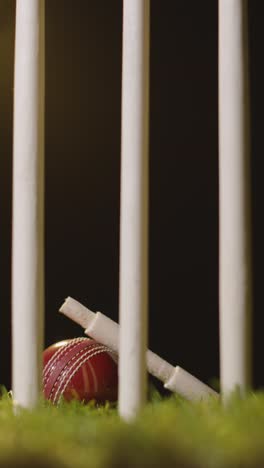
12,0,44,408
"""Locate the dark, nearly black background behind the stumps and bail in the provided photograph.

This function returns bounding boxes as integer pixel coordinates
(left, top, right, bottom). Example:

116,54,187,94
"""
0,0,264,394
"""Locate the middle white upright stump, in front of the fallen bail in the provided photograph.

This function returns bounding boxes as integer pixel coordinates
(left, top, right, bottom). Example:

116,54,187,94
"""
118,0,150,419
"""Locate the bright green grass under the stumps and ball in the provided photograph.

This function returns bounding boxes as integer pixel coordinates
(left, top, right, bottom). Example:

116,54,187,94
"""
0,393,264,468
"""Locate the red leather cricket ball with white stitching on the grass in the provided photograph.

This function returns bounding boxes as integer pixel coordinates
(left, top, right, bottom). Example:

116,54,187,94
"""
43,338,118,404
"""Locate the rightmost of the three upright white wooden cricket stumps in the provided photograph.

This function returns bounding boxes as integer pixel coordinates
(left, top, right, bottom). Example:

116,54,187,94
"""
219,0,251,394
